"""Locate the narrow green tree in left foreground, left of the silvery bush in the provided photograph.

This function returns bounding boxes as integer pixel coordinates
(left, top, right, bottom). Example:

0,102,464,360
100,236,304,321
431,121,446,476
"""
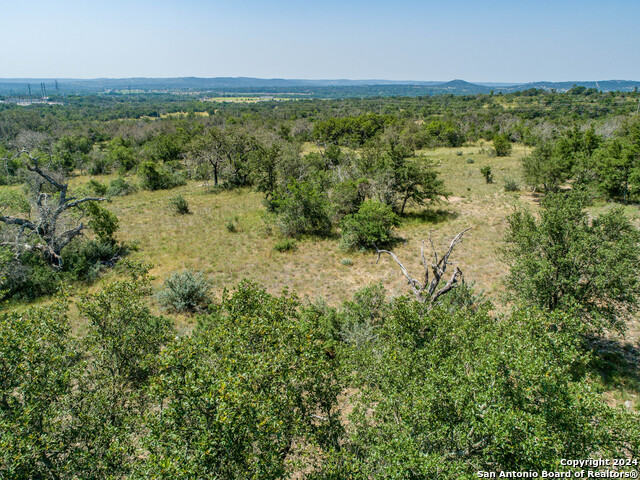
67,264,174,479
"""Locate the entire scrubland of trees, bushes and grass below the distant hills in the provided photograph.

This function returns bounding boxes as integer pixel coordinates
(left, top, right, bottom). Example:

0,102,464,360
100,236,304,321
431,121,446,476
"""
0,90,640,480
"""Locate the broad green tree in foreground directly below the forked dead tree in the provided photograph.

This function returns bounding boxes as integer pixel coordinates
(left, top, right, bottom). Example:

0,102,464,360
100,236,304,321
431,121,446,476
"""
310,298,640,480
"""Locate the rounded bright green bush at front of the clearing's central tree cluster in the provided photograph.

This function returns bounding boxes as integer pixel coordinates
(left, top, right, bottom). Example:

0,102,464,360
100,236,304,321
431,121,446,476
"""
340,200,399,249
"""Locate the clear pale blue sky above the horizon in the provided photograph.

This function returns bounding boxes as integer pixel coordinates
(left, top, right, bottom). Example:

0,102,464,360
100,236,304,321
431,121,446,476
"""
0,0,640,83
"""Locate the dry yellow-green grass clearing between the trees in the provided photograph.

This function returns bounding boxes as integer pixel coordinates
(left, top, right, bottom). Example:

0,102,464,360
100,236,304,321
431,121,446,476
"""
51,144,640,409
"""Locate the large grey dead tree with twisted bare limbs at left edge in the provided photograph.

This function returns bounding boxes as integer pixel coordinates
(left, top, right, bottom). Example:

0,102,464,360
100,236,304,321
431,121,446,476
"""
0,150,105,270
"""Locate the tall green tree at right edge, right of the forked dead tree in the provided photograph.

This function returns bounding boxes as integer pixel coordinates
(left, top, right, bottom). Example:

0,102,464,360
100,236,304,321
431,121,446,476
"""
504,191,640,331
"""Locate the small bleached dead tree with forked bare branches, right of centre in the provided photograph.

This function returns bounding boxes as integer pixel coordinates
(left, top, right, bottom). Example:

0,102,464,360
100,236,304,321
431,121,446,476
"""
374,227,471,304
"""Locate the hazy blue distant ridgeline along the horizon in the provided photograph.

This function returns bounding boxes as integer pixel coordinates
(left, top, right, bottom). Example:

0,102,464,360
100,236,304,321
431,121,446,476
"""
0,77,640,99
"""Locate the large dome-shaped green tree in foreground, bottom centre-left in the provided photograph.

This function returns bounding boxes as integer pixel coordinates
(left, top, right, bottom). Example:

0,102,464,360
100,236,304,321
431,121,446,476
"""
140,282,341,479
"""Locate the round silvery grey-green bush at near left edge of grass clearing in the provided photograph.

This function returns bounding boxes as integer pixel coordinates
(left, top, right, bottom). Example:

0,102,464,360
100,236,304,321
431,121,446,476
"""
157,270,211,312
